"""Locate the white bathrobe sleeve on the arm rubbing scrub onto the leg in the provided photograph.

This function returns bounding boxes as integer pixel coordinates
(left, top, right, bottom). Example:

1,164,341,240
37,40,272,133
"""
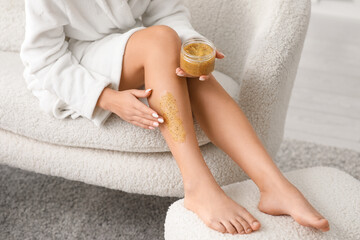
20,0,110,126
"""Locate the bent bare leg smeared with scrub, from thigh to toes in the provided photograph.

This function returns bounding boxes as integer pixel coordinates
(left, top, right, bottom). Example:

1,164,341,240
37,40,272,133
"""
119,26,260,234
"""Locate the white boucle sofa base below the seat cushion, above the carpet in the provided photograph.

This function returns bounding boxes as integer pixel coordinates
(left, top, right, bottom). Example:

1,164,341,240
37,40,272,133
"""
0,129,246,197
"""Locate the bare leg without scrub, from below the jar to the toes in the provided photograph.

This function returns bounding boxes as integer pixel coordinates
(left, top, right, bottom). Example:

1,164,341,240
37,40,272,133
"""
187,75,329,231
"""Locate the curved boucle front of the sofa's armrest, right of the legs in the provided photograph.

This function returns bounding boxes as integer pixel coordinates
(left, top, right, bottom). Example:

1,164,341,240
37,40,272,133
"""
239,0,311,158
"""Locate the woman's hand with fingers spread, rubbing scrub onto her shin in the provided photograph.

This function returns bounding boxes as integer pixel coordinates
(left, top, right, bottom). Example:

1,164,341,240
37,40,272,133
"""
97,87,164,129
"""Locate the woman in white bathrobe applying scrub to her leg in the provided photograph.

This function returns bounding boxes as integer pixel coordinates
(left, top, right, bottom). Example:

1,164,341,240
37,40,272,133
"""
20,0,329,234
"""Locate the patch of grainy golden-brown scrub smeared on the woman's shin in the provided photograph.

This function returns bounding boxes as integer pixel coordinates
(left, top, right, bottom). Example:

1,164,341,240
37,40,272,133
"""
160,92,186,142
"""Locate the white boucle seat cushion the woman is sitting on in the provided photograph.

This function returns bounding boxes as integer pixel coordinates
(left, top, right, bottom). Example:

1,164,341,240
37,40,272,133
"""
0,52,239,152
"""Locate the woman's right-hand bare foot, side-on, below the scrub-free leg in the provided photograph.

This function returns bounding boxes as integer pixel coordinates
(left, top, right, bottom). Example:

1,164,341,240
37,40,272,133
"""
258,182,330,232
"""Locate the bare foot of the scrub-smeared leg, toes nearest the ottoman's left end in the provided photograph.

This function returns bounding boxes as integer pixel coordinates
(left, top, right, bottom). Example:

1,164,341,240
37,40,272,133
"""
184,181,260,234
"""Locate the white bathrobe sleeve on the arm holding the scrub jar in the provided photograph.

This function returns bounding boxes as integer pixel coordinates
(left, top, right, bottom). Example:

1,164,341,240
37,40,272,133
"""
142,0,207,42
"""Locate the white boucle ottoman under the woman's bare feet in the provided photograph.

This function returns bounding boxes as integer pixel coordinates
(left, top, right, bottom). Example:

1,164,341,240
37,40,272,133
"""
165,167,360,240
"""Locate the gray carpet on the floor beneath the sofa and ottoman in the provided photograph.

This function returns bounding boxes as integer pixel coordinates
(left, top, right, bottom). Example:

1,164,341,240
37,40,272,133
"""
0,139,360,240
